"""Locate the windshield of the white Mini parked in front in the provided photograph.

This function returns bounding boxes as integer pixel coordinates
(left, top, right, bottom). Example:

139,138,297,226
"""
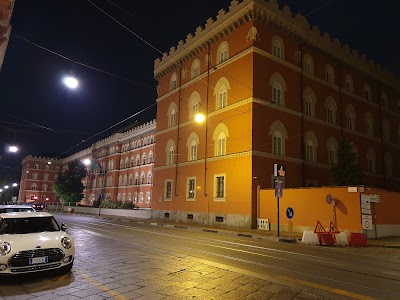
0,217,60,234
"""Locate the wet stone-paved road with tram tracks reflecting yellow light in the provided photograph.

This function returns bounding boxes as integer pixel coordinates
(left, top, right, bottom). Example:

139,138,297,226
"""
0,215,400,300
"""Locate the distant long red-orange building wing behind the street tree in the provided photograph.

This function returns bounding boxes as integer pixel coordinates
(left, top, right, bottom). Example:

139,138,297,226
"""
19,120,156,208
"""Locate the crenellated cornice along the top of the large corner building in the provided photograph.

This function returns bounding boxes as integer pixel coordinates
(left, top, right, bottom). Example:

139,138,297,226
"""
154,0,400,91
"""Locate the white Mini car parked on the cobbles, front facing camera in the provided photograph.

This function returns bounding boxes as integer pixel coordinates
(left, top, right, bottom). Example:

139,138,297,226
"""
0,212,75,275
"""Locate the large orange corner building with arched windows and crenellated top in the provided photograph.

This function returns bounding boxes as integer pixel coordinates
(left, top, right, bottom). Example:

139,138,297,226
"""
152,0,400,228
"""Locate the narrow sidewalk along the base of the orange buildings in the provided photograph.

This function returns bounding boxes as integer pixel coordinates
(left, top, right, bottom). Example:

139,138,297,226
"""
74,214,400,251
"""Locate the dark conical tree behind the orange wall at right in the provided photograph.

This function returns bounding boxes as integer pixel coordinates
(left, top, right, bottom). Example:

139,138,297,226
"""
332,138,364,186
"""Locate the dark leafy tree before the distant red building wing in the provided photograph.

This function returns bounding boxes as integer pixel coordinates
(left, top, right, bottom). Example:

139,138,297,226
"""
53,161,86,204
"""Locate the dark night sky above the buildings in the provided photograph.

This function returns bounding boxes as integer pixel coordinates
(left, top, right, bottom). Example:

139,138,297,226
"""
0,0,400,182
